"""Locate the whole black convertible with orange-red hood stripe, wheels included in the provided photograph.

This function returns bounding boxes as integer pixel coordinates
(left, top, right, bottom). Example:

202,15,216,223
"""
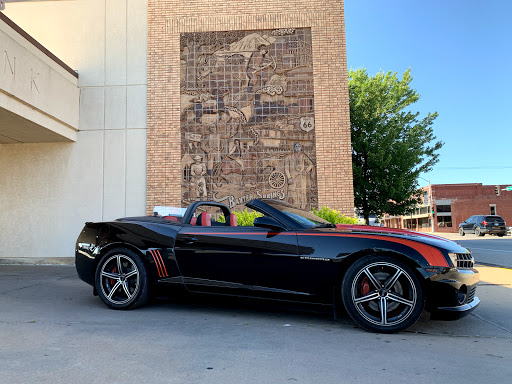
76,199,480,333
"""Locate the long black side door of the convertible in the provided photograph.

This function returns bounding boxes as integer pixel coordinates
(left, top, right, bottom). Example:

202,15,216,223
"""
175,226,298,296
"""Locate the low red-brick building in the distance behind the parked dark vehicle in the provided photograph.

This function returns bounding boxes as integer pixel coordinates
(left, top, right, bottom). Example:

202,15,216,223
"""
382,183,512,232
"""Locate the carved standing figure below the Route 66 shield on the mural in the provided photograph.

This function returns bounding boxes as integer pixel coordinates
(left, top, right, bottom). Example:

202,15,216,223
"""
285,143,314,209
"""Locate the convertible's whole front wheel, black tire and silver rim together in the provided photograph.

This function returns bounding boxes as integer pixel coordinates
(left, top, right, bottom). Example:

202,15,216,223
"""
341,255,425,333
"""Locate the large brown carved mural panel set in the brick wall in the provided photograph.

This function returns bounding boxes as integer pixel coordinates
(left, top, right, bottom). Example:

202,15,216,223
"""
180,28,317,209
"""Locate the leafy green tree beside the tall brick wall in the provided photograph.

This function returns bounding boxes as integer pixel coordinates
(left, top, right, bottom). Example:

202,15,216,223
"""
348,69,443,223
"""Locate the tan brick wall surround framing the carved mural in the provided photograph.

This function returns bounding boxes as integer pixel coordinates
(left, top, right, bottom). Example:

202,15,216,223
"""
147,0,354,215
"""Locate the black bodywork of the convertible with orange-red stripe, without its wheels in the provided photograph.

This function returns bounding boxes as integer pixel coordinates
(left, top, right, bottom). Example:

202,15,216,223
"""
76,200,478,328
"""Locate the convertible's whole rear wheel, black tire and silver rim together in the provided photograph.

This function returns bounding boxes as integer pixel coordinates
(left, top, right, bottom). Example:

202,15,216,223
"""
95,248,150,309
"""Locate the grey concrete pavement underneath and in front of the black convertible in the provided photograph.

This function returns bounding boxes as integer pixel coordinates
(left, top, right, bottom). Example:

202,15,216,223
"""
0,265,512,384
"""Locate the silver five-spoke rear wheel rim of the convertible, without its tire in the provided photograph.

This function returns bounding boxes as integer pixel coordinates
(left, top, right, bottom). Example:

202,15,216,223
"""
100,254,140,305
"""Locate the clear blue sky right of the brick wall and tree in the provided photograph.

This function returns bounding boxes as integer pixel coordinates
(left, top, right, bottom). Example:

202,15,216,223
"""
345,0,512,186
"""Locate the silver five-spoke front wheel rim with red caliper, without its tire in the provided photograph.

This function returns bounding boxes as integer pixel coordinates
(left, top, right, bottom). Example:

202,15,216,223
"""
351,262,418,327
